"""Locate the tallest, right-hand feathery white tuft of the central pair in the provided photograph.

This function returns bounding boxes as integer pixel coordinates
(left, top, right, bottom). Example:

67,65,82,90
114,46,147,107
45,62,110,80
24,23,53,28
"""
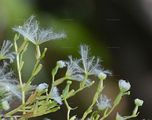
80,45,110,76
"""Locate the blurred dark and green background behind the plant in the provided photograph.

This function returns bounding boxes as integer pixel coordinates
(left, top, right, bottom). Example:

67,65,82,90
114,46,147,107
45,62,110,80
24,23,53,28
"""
0,0,152,120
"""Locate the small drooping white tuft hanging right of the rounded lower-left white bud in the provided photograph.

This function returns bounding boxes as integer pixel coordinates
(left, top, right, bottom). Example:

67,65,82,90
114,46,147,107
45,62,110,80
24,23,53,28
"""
50,87,62,105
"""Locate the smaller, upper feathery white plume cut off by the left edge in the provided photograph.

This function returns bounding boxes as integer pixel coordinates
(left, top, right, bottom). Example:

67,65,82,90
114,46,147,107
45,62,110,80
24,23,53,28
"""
0,40,15,62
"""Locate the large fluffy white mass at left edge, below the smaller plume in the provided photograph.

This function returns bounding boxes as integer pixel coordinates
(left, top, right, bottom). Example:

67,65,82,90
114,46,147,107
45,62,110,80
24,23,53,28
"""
0,63,21,100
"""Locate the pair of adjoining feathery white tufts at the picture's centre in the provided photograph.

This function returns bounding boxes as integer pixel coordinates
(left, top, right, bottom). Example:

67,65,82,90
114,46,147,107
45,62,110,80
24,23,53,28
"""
66,45,110,81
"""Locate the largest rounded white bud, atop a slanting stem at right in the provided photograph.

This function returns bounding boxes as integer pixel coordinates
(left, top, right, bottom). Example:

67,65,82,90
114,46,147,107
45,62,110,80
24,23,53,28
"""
119,80,131,92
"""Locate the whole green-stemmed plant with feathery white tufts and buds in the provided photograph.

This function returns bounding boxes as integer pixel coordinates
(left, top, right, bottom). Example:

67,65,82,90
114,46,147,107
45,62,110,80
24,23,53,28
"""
0,16,143,120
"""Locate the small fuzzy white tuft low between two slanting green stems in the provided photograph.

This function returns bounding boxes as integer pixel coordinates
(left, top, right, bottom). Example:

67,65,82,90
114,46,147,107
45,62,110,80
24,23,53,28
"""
97,95,111,110
